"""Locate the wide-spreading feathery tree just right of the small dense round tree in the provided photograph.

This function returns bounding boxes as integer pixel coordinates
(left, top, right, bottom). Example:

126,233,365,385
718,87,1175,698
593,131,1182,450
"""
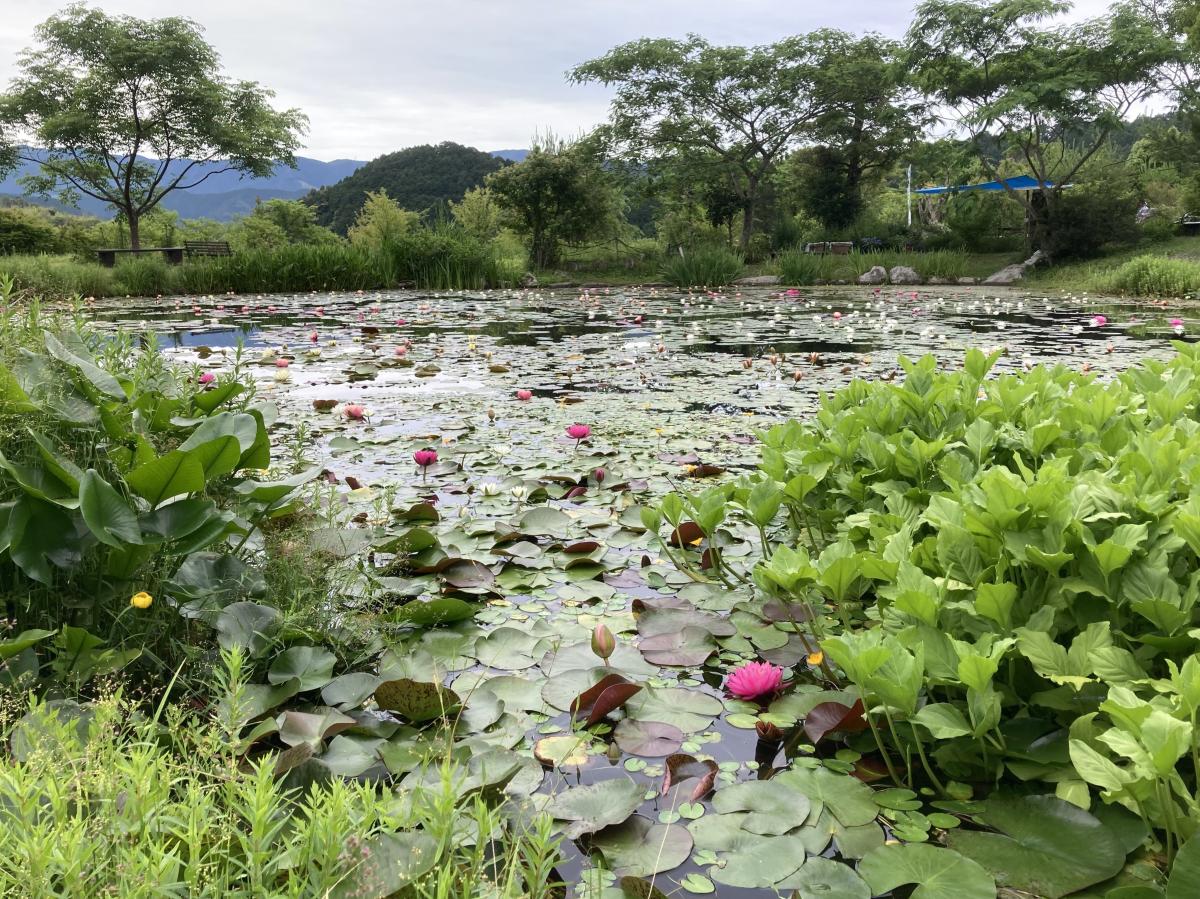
570,31,834,250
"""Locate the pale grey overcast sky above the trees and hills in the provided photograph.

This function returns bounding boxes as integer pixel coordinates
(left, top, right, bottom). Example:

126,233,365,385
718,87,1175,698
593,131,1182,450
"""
0,0,1108,160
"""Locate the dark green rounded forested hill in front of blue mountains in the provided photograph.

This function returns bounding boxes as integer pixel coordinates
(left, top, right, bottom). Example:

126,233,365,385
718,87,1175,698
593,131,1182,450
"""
304,142,509,234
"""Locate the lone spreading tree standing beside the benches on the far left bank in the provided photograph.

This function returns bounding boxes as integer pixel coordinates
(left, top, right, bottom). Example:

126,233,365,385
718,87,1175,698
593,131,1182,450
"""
0,5,306,248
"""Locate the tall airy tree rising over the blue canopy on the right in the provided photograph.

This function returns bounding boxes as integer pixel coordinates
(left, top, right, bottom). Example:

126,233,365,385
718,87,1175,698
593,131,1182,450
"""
908,0,1178,254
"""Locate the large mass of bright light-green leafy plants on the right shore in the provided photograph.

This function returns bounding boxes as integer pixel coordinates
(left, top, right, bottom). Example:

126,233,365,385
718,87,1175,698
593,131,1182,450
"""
658,344,1200,854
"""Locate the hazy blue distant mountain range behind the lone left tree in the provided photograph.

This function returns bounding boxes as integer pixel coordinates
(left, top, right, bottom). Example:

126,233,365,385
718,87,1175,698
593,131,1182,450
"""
0,150,528,222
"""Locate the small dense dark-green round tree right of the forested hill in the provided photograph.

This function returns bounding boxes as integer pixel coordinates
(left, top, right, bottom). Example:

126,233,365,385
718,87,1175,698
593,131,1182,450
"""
487,137,624,269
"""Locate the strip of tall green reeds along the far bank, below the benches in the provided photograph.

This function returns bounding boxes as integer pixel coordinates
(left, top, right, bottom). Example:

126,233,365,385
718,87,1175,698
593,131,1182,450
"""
0,228,520,299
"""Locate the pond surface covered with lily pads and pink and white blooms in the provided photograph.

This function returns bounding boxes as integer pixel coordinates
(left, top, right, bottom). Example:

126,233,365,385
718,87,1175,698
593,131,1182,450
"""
89,288,1196,898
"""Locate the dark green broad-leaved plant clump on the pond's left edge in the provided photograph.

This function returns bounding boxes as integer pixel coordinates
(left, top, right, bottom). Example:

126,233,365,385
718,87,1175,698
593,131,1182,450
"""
0,308,316,681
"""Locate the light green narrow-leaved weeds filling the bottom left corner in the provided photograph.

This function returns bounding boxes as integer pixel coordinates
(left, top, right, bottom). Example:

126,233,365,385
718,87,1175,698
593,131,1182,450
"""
0,655,557,899
